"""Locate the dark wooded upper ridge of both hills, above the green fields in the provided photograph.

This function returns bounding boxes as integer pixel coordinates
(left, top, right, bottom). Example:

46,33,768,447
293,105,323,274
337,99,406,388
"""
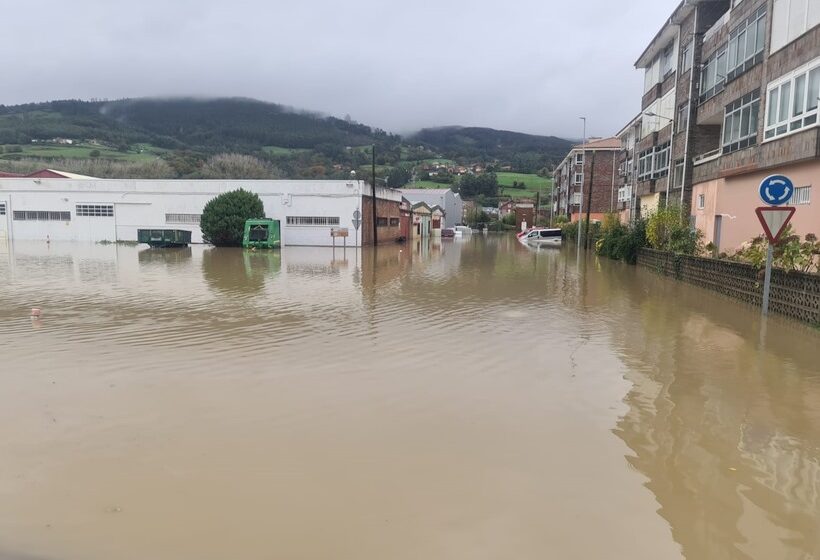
0,98,571,169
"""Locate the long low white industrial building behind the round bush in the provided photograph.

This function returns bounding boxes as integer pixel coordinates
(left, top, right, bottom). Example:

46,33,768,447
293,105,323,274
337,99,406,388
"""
0,178,401,246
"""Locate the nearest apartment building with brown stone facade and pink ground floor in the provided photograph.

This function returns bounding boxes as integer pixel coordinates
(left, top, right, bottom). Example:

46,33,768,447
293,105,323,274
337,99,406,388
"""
636,0,820,250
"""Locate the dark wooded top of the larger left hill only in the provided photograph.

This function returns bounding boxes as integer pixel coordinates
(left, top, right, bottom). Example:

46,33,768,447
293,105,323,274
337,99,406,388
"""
0,98,388,152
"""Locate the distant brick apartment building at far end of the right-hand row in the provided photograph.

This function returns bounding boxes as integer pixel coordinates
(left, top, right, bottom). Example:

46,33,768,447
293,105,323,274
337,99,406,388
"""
553,137,621,222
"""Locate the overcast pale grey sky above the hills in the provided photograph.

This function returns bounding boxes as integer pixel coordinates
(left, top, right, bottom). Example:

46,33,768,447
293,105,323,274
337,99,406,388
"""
0,0,678,137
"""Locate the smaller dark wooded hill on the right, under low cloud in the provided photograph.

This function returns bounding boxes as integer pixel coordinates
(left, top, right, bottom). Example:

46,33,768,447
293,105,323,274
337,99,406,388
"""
407,126,572,169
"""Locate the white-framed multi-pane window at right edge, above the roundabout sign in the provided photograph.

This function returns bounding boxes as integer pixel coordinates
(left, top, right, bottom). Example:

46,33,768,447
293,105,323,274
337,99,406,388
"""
765,58,820,140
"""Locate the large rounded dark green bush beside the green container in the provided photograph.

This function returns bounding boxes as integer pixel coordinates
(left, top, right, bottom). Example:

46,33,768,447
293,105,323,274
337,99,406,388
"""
200,189,265,247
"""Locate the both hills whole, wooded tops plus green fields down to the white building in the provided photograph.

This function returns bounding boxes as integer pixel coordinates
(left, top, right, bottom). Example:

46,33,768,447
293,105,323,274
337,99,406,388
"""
0,98,570,174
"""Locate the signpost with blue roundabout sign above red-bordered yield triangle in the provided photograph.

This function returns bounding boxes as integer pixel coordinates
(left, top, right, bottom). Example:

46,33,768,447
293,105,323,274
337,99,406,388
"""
755,175,796,315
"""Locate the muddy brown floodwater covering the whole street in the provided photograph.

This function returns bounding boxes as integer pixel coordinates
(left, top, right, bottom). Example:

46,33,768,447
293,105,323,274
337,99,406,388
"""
0,235,820,560
